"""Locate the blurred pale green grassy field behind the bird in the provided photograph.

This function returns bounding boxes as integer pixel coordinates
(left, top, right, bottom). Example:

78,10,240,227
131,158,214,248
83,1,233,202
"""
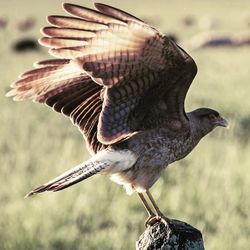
0,0,250,250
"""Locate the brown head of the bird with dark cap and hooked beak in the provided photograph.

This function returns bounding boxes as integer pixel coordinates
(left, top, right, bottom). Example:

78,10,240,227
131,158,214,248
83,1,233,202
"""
188,108,228,136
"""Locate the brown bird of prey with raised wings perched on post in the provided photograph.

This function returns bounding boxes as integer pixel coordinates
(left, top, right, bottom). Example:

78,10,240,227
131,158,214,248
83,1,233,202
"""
7,3,227,225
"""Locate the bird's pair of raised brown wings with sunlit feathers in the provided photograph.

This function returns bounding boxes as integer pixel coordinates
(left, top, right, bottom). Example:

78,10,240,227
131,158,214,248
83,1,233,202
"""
8,4,196,152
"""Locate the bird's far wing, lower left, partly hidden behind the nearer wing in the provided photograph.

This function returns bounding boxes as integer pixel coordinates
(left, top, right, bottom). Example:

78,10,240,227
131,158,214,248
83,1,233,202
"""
7,59,104,153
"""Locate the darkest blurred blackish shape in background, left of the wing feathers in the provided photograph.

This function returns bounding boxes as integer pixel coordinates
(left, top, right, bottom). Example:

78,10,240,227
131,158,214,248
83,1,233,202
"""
12,38,40,53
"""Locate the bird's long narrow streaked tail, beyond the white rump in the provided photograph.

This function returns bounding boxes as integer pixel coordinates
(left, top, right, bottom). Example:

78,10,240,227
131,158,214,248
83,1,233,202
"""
25,162,109,198
